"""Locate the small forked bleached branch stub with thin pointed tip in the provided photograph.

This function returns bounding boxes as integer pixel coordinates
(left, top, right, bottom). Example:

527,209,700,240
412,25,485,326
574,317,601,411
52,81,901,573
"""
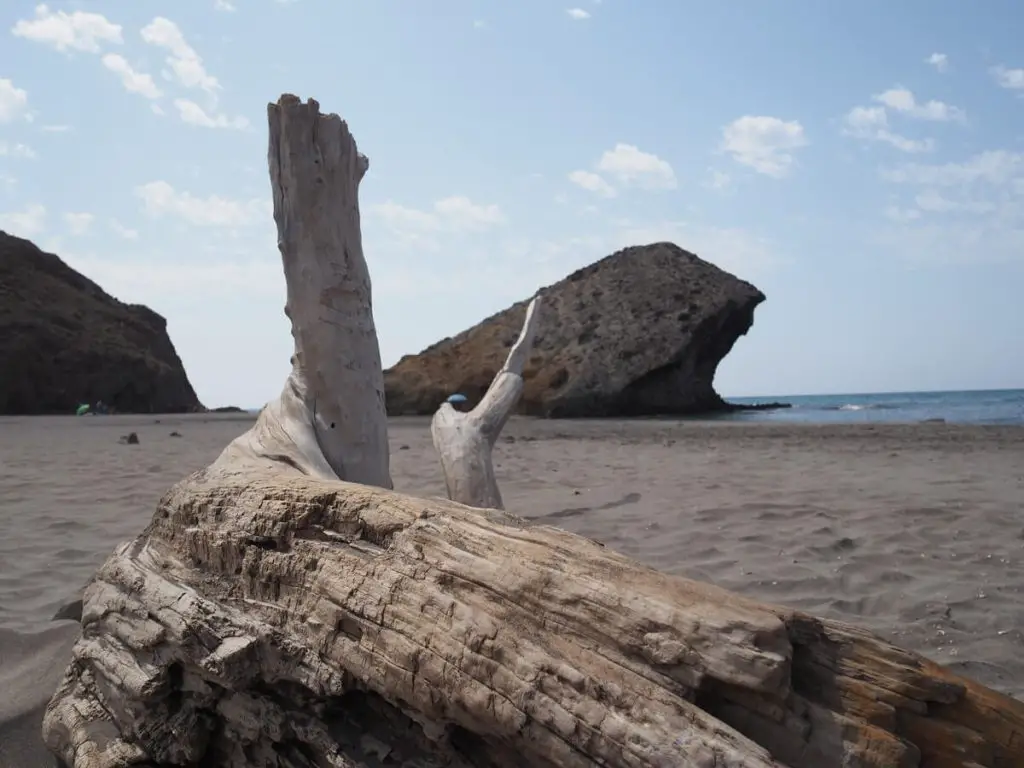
430,296,540,509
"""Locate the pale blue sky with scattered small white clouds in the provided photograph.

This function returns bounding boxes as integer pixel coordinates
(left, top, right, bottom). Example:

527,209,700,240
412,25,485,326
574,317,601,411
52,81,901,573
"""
0,0,1024,406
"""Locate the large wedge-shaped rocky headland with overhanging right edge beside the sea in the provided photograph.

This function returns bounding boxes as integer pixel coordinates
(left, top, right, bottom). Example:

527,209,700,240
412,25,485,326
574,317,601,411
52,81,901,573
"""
384,243,765,418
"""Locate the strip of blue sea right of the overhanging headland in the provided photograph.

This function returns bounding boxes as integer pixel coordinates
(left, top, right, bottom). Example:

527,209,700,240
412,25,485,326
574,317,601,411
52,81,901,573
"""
722,389,1024,425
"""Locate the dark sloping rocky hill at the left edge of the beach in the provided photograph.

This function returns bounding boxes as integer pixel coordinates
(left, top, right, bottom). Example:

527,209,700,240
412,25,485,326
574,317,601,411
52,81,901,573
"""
0,231,202,414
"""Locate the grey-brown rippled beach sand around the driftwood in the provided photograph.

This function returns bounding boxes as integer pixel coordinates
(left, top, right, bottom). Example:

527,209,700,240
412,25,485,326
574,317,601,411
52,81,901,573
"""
0,416,1024,768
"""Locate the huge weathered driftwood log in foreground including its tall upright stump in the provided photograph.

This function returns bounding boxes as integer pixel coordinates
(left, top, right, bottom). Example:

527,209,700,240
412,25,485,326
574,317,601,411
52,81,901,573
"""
43,96,1024,768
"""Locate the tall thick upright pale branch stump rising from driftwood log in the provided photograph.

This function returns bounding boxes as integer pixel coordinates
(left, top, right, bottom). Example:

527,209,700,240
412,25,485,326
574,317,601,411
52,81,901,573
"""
219,95,392,488
